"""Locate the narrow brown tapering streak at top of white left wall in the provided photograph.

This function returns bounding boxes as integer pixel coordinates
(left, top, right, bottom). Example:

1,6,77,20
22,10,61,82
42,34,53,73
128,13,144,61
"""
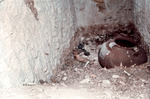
24,0,39,21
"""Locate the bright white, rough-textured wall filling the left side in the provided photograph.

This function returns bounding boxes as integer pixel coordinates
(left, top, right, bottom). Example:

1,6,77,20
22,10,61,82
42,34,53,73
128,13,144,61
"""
0,0,75,87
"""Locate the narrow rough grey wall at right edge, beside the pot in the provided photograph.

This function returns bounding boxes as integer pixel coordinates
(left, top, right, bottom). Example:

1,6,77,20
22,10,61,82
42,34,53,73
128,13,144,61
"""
132,0,150,53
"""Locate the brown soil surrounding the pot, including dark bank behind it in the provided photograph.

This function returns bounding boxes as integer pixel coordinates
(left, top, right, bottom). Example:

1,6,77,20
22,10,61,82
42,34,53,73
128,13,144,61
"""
51,24,150,99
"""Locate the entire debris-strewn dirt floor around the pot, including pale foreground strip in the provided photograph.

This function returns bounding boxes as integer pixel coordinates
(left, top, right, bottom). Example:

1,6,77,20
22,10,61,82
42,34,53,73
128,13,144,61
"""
0,24,150,99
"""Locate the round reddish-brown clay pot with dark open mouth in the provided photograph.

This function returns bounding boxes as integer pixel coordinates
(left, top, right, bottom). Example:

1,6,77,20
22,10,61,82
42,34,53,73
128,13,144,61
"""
98,37,147,68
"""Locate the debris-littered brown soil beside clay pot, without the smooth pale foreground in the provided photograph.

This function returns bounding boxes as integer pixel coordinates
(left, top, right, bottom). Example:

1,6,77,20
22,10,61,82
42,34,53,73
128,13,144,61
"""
54,32,150,99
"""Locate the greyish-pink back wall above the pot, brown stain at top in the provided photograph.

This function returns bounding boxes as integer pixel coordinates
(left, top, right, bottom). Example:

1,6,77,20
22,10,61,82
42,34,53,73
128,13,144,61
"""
74,0,133,27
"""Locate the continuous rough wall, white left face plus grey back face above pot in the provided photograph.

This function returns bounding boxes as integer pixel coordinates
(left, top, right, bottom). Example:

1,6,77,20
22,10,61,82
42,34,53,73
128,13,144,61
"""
0,0,132,87
